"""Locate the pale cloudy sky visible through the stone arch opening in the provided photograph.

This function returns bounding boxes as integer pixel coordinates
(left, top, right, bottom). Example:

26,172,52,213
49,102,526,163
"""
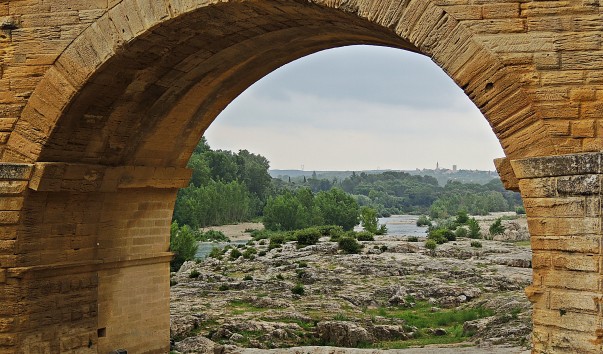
205,46,504,171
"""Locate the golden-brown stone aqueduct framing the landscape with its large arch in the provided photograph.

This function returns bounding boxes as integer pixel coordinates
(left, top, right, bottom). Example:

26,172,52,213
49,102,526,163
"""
0,0,603,353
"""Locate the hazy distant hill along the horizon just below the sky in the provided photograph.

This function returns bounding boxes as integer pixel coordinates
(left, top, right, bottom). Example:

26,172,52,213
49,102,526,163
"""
268,169,499,186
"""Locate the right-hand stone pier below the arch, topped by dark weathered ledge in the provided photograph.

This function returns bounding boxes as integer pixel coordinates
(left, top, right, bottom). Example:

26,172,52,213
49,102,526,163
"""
512,153,603,353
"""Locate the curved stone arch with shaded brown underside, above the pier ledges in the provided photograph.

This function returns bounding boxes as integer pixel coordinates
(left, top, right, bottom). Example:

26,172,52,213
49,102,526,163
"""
4,0,552,167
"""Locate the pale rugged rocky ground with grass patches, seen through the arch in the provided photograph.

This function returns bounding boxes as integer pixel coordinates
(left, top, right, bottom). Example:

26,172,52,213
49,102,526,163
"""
171,220,532,354
